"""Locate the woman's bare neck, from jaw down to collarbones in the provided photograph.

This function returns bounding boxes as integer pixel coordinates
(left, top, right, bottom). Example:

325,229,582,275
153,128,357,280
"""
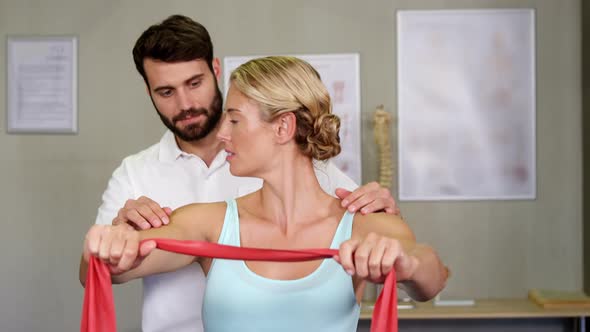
260,153,333,232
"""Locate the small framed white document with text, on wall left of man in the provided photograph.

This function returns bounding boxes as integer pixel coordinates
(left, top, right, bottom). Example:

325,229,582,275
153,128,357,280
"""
7,37,77,133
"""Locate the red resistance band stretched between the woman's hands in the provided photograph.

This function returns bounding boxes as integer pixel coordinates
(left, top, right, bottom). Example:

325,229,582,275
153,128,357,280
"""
80,239,397,332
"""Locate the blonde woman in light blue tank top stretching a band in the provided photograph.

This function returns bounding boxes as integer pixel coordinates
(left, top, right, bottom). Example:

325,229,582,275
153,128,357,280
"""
81,57,447,331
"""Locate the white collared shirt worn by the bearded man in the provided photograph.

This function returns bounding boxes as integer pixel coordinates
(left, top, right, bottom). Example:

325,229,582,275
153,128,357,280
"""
96,131,357,332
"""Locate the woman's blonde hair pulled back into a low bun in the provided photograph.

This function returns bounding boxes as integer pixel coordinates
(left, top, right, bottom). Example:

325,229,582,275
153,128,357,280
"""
230,56,340,160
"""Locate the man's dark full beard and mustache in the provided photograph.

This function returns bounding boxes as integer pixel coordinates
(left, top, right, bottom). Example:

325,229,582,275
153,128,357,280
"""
152,87,223,142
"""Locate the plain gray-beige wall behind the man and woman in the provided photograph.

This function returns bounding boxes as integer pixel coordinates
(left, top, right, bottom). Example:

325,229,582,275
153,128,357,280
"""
0,0,582,331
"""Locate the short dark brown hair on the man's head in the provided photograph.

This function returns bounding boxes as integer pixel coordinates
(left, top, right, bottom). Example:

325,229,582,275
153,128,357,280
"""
133,15,213,85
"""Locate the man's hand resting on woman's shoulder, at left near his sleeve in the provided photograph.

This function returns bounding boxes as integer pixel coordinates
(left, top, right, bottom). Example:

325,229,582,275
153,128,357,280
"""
113,196,172,229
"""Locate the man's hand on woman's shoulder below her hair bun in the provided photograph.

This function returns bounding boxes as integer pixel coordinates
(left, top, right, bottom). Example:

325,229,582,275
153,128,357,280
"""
336,182,400,215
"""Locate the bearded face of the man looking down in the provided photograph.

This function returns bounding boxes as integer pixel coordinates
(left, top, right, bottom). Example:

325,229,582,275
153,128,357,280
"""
144,58,223,142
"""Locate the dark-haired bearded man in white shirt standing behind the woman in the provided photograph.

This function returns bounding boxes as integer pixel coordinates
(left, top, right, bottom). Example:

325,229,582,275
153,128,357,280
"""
90,15,397,332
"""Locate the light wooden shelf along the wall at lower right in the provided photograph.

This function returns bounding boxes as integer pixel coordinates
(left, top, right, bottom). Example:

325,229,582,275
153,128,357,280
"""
360,299,590,319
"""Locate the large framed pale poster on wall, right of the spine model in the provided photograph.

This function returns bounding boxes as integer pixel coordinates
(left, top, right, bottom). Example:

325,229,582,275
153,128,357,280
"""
397,9,536,201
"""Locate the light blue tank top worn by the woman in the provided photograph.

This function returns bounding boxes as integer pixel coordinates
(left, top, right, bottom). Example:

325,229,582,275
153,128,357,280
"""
203,200,360,332
